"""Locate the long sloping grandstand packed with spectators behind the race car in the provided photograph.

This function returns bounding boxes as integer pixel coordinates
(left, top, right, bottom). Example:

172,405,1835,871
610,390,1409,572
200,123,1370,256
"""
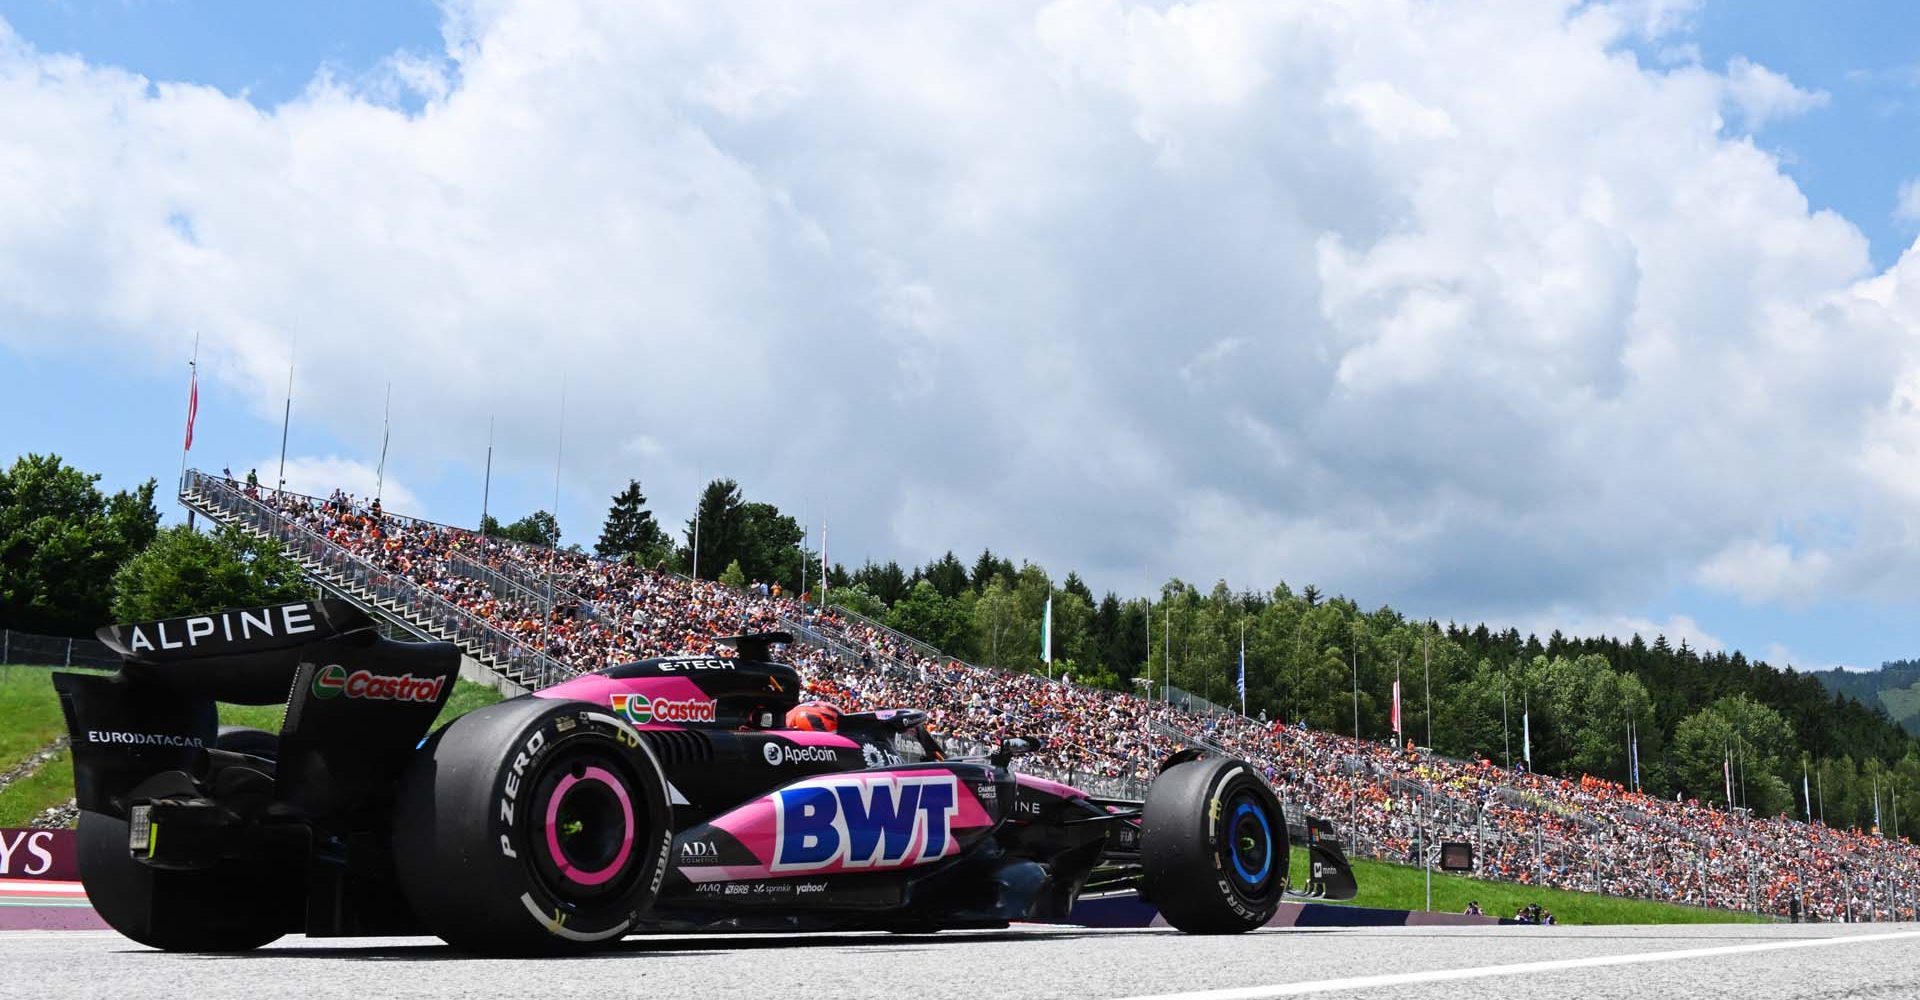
180,472,1920,921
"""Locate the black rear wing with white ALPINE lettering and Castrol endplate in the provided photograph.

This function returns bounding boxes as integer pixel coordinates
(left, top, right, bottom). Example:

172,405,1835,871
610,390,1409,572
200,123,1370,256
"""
54,601,461,816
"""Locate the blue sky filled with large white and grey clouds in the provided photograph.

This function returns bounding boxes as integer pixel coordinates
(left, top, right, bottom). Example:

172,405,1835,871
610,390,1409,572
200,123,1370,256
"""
0,0,1920,668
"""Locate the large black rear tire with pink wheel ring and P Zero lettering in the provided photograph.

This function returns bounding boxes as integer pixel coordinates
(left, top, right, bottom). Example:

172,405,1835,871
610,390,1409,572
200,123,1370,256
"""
394,699,672,954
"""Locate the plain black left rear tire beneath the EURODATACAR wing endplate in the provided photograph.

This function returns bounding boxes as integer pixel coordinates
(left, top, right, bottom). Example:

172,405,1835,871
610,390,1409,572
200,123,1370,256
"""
75,810,289,952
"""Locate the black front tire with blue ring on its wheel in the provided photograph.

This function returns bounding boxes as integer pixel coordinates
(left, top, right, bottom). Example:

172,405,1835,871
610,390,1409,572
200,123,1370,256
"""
1140,756,1288,935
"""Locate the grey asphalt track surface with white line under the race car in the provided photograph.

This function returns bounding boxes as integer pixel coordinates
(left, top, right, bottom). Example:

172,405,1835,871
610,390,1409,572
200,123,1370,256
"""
0,923,1920,1000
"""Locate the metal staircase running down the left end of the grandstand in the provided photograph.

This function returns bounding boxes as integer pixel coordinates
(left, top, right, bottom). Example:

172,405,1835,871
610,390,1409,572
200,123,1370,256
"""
180,470,578,689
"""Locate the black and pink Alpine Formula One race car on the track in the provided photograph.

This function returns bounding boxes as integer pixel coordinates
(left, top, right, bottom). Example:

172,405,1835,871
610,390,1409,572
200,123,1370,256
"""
54,601,1354,954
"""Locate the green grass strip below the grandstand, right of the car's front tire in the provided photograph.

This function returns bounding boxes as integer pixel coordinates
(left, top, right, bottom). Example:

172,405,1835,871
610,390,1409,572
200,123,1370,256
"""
1292,848,1761,923
